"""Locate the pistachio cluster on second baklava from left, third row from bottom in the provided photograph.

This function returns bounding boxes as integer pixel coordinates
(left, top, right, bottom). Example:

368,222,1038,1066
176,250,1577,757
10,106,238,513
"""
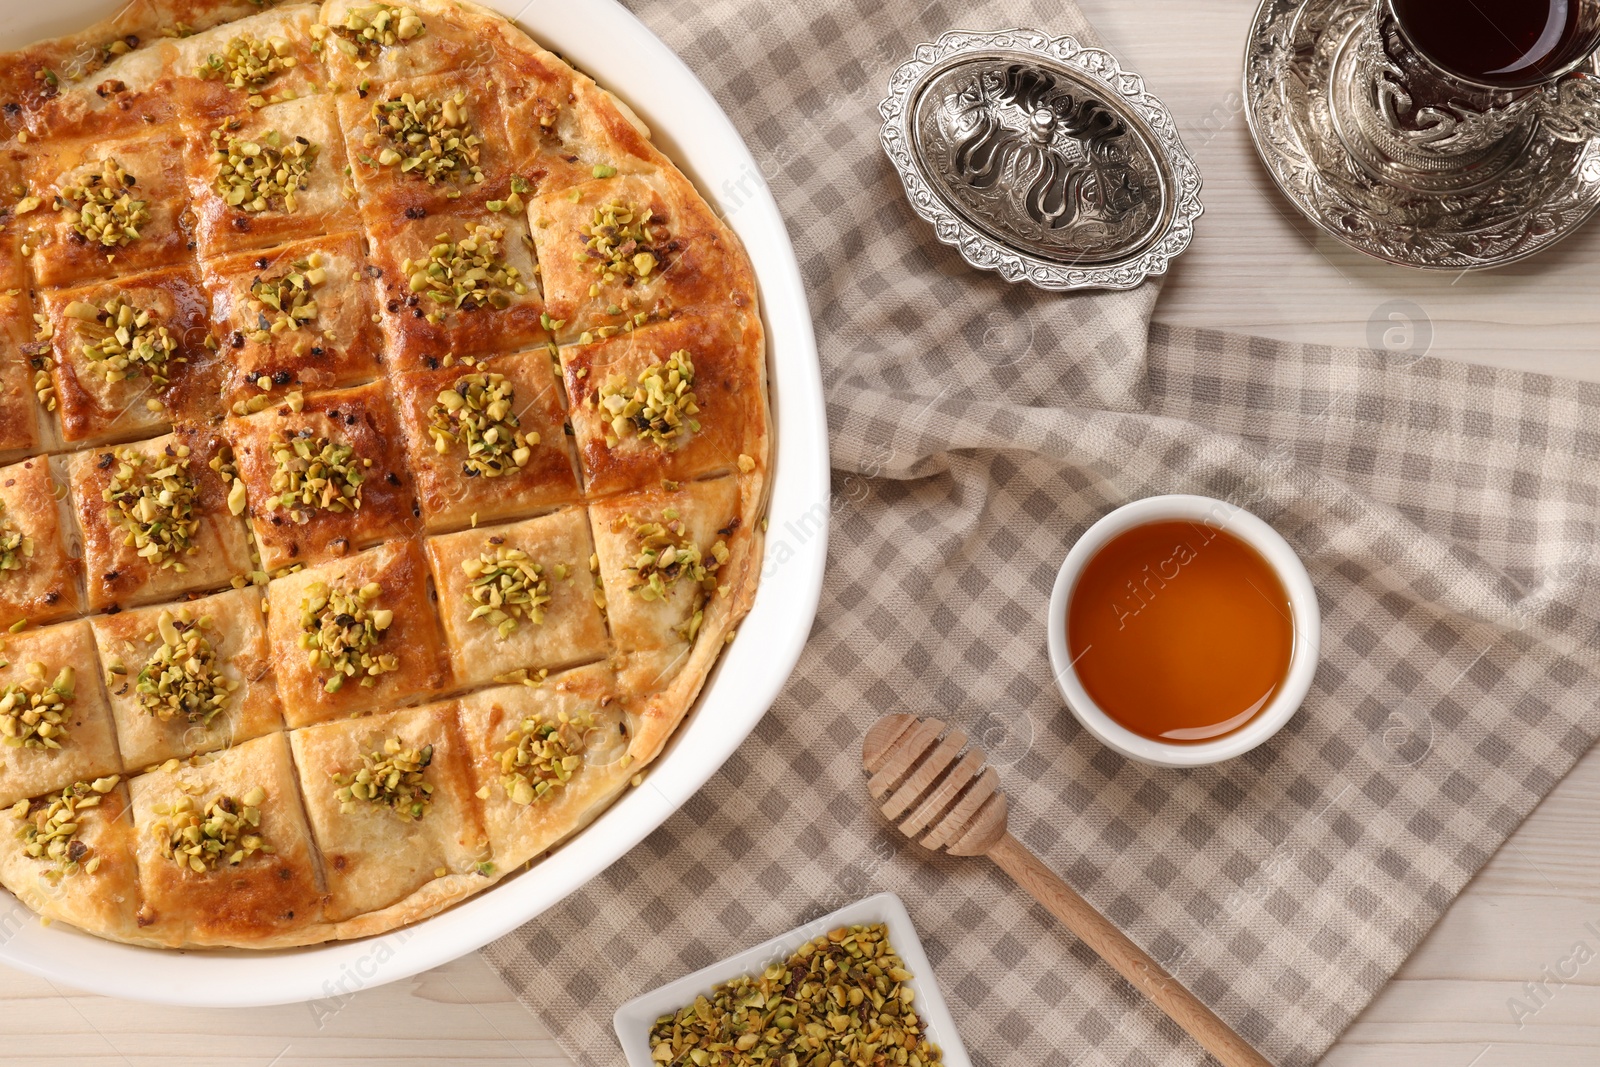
101,445,200,573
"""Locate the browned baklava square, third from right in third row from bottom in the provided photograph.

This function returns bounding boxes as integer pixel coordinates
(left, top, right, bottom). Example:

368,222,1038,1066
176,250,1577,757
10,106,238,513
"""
229,382,419,571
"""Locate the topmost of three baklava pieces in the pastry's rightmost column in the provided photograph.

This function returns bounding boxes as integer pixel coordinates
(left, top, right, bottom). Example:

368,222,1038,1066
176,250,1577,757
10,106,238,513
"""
530,171,755,344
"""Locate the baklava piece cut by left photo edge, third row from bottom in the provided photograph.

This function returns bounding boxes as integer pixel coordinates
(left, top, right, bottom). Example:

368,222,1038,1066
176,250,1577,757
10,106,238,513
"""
0,456,83,627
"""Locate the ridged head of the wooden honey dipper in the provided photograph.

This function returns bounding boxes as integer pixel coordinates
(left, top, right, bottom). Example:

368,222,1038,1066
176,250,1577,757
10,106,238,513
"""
861,715,1006,856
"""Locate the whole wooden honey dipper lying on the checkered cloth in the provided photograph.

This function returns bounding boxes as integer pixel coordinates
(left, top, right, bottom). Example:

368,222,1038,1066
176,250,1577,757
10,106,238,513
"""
861,715,1272,1067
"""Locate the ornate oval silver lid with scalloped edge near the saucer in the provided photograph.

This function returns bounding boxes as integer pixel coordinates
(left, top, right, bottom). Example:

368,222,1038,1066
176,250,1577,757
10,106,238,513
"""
878,29,1202,290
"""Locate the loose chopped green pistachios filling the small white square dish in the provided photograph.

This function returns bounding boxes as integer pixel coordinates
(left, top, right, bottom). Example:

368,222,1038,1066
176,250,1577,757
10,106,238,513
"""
650,923,944,1067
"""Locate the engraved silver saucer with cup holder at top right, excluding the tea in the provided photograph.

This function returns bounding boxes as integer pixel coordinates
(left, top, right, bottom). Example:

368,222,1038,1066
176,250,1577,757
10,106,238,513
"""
1245,0,1600,270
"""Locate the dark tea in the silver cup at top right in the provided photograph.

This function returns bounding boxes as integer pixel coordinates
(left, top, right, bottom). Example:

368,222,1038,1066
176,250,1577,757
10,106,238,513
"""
1389,0,1600,90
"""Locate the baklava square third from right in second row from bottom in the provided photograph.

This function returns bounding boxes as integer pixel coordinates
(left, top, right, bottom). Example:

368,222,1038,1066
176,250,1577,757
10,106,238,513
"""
267,541,450,728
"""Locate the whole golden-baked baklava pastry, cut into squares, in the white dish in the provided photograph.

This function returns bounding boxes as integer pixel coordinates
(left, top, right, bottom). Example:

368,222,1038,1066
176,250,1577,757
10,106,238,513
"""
0,0,770,949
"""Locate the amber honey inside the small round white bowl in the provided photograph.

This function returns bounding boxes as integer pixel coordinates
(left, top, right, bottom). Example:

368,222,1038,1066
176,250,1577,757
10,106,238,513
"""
1067,522,1294,744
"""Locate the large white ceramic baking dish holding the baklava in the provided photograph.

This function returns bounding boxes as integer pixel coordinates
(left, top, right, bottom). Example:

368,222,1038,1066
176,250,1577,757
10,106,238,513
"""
0,0,829,1006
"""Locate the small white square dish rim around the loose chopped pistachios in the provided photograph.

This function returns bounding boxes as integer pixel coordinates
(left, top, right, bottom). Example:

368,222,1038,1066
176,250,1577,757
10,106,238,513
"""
611,893,971,1067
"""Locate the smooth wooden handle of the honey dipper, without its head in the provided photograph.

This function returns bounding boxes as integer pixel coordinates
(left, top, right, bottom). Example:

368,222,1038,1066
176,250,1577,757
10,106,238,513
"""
989,833,1272,1067
